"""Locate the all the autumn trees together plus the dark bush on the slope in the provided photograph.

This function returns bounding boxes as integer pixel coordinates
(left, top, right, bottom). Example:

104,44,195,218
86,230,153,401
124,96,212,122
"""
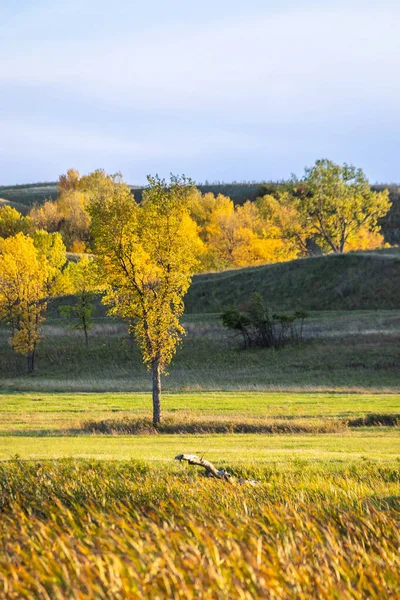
0,160,390,424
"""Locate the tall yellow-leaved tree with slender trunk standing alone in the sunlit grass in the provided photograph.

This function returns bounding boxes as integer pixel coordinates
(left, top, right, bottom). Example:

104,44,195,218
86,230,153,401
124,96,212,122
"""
89,176,201,426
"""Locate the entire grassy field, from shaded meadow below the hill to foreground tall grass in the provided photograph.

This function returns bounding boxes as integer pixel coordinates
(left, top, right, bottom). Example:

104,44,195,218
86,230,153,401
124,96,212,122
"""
0,264,400,600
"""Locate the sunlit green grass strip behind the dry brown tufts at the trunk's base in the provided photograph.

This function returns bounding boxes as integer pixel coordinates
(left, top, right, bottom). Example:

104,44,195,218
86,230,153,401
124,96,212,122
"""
0,392,400,434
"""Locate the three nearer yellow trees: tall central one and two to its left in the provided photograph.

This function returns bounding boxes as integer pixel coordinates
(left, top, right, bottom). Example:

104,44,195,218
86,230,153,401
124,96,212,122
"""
0,171,202,424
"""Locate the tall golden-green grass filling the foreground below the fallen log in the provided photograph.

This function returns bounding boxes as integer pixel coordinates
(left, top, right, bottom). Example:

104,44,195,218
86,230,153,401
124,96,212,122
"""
0,461,400,600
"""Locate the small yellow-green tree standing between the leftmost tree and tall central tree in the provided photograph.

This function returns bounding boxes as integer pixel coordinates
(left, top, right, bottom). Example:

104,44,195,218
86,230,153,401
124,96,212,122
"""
59,256,99,347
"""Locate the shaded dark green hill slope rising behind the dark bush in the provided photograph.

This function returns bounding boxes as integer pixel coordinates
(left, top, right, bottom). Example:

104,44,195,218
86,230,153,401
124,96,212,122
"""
185,248,400,313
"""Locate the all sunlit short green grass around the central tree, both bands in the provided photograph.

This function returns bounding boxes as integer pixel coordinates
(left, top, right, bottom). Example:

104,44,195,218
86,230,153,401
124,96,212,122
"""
0,392,400,464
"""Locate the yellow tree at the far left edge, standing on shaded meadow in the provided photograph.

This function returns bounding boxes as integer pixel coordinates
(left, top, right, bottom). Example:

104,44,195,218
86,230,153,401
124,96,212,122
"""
0,232,65,373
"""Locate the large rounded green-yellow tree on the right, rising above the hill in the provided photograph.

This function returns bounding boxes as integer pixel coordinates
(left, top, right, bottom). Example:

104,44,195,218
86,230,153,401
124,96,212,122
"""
257,160,390,254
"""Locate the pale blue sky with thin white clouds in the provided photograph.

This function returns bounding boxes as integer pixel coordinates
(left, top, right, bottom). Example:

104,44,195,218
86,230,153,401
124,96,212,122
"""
0,0,400,185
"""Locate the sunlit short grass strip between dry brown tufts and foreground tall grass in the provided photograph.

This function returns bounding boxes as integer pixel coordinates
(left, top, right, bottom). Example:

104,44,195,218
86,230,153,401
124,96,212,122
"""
0,428,400,468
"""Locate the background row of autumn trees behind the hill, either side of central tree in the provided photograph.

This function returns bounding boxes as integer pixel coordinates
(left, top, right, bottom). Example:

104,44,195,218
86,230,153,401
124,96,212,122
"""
0,160,390,271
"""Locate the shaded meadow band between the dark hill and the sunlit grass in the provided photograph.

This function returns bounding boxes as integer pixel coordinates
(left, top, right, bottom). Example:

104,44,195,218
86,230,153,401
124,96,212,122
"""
0,311,400,392
